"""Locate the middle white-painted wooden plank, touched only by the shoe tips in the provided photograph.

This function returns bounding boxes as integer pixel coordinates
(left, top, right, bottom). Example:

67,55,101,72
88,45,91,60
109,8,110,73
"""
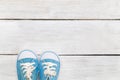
0,20,120,54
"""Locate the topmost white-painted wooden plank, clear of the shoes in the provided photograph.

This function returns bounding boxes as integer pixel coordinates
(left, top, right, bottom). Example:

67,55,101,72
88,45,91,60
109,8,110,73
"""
0,0,120,19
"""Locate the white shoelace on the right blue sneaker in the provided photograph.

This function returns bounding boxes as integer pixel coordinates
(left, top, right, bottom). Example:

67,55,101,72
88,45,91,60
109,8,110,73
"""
42,62,57,77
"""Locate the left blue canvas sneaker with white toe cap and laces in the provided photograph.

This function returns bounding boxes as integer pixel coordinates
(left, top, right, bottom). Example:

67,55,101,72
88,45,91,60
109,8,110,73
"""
16,50,39,80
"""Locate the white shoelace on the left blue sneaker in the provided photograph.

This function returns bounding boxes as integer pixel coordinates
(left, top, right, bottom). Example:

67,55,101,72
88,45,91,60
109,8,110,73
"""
20,62,35,80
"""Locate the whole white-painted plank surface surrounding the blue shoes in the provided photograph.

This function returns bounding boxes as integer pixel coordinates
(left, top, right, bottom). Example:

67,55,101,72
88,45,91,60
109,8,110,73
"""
0,0,120,80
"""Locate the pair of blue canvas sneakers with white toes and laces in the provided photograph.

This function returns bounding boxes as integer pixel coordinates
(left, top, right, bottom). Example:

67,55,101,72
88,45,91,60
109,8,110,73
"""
16,50,60,80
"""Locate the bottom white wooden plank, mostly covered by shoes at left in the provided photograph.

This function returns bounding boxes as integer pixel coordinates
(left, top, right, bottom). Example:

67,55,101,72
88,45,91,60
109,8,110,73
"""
0,56,120,80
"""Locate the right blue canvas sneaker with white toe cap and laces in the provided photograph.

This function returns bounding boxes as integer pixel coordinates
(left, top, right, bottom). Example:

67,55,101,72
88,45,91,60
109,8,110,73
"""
39,51,60,80
